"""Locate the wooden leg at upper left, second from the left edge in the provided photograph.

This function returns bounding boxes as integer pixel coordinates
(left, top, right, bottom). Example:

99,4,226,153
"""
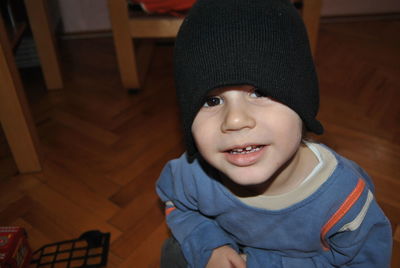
25,0,63,89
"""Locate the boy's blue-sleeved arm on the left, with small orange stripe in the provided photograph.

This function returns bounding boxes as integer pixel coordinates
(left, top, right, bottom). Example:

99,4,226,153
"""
157,163,240,267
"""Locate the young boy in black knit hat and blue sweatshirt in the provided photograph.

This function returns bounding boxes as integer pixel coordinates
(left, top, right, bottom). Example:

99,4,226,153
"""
157,0,391,268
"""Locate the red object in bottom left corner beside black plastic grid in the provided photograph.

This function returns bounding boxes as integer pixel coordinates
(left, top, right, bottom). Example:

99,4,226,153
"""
0,227,32,268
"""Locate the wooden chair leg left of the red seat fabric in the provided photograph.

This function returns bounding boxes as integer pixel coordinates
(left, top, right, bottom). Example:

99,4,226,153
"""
108,0,141,90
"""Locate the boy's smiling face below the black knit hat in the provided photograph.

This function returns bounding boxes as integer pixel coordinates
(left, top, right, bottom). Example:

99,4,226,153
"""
192,85,302,189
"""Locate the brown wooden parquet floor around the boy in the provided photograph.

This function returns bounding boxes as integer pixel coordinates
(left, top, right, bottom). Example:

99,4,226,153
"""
0,18,400,268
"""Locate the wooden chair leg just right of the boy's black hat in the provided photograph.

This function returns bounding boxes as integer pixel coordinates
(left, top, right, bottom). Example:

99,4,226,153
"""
302,0,322,56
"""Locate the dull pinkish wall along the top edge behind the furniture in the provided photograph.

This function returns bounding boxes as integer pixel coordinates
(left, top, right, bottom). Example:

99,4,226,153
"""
58,0,400,33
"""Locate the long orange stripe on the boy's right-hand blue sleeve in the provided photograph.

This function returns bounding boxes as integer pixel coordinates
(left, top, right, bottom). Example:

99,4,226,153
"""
321,179,365,250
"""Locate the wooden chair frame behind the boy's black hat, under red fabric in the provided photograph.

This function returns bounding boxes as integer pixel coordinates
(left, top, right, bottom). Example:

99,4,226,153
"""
108,0,322,90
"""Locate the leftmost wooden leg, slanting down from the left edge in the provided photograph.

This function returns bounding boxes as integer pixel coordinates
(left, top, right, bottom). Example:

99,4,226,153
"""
0,16,41,173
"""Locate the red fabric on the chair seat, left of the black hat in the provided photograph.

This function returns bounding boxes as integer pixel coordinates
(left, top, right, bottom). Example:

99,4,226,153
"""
132,0,196,16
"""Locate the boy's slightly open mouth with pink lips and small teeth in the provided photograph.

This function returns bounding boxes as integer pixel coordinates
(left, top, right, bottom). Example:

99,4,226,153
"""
224,144,266,167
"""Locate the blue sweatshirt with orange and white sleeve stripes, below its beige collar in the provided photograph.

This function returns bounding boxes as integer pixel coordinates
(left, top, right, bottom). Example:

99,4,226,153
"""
157,145,392,268
